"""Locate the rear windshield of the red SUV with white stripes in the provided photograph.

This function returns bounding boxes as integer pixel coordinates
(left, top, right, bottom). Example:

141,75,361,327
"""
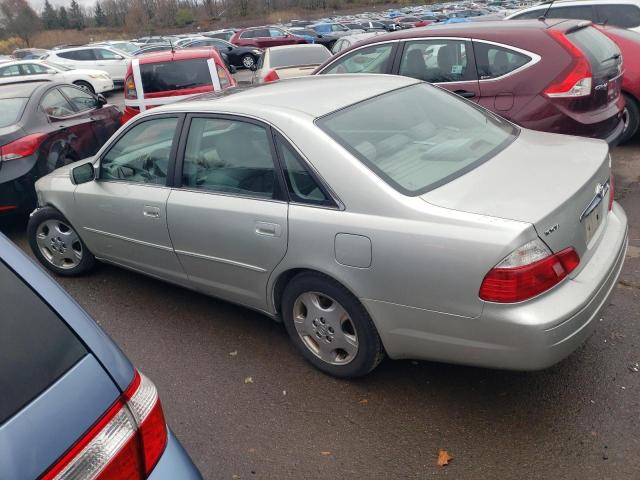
140,58,212,93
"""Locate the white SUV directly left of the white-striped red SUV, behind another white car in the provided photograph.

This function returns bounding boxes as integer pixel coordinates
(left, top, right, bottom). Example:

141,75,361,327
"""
43,46,135,83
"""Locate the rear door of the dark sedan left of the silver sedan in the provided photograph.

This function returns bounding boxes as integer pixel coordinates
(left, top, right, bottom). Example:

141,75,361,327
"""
40,87,98,173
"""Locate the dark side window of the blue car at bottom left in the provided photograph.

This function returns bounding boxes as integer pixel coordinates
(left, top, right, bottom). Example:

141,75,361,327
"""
0,262,87,424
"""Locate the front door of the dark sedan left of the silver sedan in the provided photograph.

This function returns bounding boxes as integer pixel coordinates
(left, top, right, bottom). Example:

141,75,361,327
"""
60,85,120,150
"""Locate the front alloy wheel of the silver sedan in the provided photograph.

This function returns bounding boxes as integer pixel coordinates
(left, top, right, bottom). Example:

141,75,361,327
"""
36,220,83,270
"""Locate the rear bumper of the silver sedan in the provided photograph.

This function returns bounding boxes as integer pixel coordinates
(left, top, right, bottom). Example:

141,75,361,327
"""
363,203,627,370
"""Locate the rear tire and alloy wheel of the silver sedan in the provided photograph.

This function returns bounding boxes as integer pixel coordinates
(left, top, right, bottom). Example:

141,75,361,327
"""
282,272,384,378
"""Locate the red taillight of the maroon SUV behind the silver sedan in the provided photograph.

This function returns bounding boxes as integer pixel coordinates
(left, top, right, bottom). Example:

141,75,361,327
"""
544,30,593,98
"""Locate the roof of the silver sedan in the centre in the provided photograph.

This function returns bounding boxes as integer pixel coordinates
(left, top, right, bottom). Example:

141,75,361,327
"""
152,74,421,118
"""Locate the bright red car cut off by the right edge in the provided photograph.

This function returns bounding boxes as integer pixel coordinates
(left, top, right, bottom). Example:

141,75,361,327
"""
597,27,640,143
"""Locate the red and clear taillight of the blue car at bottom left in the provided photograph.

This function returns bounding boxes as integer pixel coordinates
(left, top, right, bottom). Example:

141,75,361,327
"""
42,371,167,480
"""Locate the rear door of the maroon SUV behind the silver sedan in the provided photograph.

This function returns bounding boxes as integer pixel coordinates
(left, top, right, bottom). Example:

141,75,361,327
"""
394,38,480,102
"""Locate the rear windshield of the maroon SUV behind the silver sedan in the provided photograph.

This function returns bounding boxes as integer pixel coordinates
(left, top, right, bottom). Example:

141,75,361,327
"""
567,27,622,78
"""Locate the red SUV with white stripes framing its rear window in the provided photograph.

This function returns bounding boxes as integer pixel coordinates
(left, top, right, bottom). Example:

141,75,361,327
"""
122,48,236,123
